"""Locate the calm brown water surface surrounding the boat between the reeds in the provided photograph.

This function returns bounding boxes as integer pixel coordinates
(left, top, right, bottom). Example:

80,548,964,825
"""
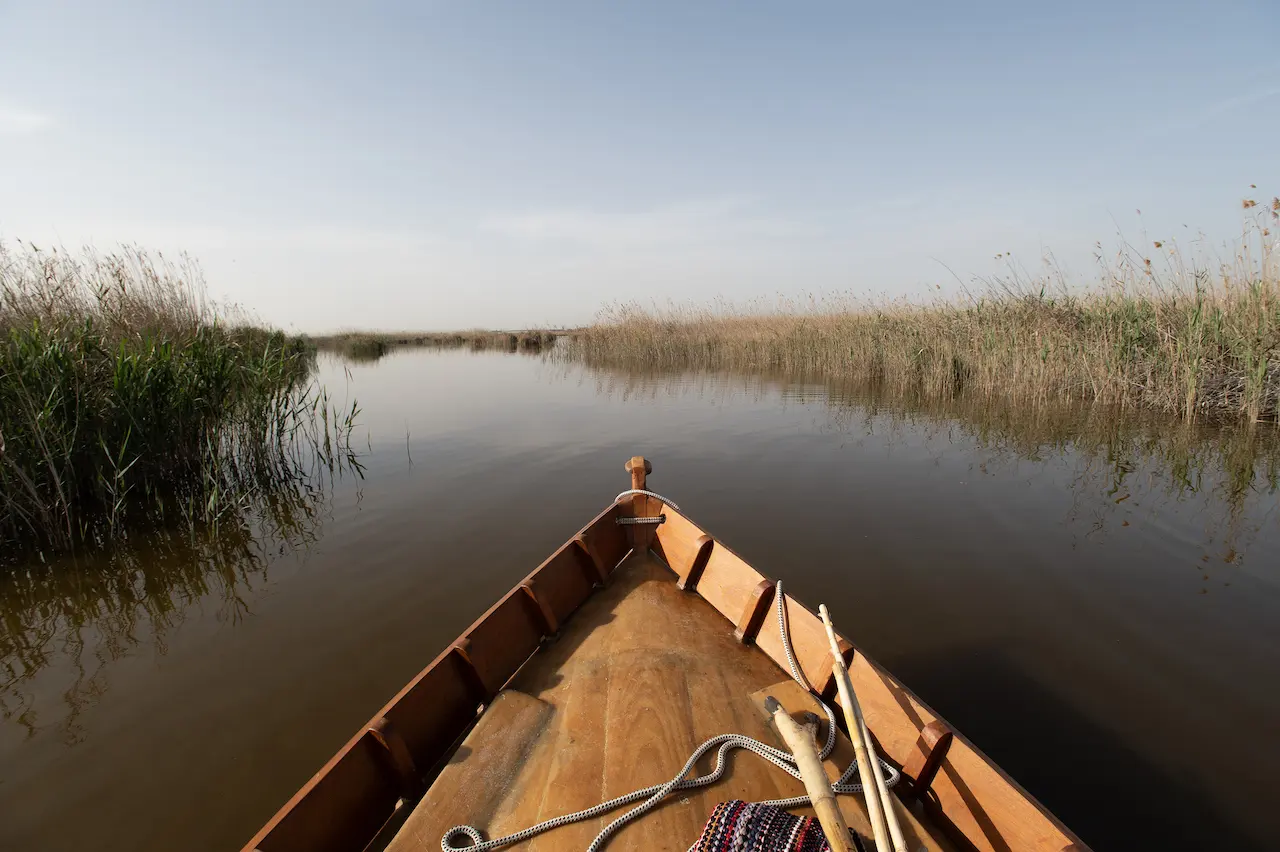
0,352,1280,851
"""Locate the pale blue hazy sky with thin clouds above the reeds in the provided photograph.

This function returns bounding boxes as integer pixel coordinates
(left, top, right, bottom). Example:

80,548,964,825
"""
0,0,1280,331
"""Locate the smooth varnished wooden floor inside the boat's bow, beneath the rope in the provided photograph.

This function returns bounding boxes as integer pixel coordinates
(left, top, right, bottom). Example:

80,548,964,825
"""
388,554,948,852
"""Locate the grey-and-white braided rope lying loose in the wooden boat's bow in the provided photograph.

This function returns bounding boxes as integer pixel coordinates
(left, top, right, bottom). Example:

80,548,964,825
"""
440,573,901,852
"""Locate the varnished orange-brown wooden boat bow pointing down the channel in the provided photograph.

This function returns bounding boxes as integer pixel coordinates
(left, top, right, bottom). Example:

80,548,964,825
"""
244,455,1085,852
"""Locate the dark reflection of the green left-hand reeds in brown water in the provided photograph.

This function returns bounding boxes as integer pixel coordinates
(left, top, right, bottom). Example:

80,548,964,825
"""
0,455,362,743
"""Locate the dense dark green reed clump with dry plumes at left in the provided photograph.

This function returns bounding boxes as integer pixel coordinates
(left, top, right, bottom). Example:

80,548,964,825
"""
0,243,357,553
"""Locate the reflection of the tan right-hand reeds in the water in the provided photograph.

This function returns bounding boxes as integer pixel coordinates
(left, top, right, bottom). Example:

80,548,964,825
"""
583,370,1280,564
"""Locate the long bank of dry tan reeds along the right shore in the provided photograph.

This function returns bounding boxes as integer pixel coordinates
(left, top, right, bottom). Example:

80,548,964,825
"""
563,198,1280,421
